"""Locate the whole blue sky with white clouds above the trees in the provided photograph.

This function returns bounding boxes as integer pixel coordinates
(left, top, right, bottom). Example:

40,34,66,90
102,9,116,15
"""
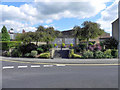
0,0,119,35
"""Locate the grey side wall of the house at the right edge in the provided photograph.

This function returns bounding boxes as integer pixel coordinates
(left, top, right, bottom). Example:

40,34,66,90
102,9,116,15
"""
112,19,119,41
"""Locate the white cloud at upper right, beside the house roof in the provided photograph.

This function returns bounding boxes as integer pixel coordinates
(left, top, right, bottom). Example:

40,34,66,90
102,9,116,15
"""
97,0,118,34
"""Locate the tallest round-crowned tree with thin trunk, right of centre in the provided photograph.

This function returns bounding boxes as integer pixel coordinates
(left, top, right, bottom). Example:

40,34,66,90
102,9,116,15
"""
81,21,103,47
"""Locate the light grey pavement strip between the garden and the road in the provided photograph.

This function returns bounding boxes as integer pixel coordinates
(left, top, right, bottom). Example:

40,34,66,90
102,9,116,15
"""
0,57,119,64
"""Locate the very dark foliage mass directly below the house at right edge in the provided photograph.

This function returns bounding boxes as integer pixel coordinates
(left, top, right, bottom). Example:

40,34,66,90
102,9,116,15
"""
104,38,118,49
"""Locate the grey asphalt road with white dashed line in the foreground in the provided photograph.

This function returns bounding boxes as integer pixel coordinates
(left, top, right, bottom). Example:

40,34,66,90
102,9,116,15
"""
2,61,118,88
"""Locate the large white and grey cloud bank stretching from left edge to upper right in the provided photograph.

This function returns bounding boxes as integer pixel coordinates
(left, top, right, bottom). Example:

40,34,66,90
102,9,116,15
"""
0,0,116,31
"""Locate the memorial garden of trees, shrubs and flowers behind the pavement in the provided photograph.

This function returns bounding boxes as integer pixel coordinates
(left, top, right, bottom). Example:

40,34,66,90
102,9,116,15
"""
0,21,118,59
